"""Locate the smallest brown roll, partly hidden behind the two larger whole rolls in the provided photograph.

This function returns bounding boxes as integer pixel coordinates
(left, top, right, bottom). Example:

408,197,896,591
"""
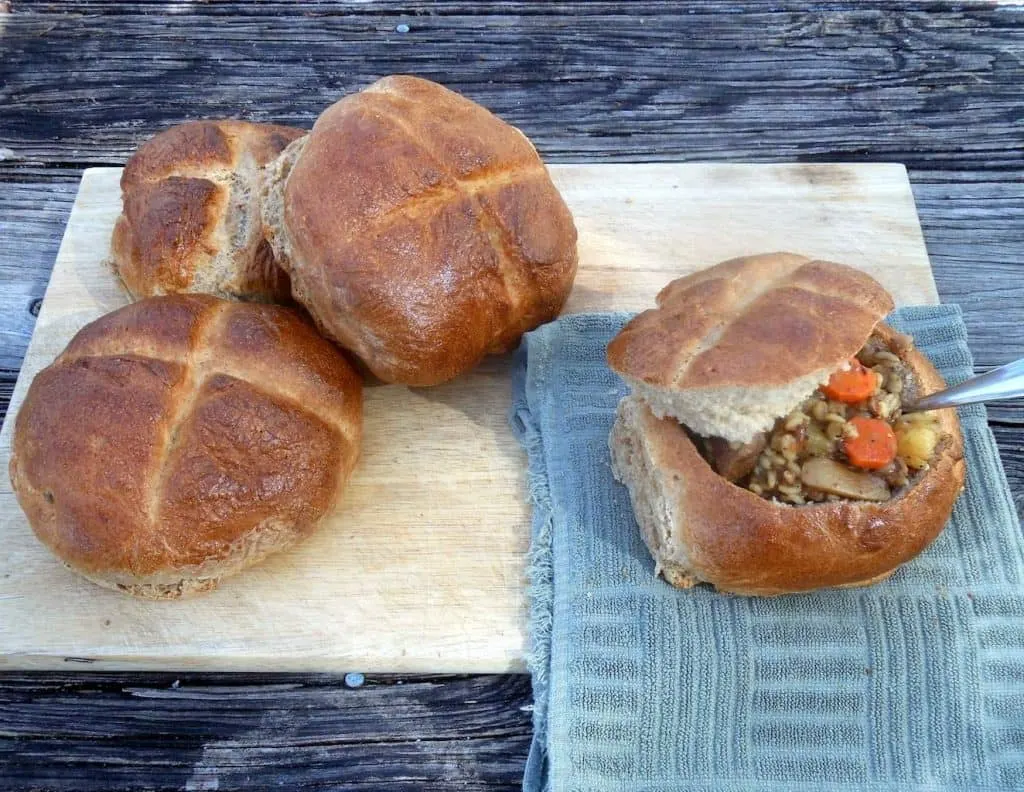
111,121,305,302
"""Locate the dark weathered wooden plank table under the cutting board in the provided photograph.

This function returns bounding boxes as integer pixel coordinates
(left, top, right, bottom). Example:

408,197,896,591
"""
0,0,1024,790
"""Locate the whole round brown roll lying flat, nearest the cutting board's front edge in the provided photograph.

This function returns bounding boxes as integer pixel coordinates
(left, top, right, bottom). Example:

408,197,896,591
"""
10,294,362,598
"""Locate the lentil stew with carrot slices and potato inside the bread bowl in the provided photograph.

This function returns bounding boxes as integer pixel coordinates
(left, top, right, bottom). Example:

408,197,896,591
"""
700,334,942,505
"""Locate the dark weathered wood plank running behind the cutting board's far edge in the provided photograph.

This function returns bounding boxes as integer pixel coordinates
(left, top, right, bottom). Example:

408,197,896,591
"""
0,2,1024,170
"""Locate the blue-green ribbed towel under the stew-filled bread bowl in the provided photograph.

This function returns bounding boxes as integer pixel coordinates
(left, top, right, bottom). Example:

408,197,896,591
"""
511,306,1024,792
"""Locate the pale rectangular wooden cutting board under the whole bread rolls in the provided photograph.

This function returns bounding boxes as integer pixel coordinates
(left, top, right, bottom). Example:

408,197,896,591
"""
0,164,937,672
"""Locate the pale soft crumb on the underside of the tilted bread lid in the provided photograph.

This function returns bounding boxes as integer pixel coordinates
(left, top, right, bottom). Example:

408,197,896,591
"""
627,364,840,443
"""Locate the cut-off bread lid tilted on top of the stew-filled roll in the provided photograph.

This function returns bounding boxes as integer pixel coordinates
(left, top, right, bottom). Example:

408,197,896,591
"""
607,253,893,443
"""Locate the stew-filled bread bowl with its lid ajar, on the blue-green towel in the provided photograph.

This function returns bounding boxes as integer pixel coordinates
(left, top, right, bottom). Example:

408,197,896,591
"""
608,254,965,594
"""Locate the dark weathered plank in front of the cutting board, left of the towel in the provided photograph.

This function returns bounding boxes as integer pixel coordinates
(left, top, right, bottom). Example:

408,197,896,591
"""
0,673,530,792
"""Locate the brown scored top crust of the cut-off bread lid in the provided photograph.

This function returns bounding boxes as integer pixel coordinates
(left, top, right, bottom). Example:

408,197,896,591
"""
607,253,893,391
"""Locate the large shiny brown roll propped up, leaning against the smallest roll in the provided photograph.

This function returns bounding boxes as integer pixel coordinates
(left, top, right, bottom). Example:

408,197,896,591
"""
262,77,577,385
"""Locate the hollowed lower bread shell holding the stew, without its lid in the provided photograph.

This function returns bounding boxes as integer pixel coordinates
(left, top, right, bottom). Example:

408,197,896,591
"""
610,325,965,595
